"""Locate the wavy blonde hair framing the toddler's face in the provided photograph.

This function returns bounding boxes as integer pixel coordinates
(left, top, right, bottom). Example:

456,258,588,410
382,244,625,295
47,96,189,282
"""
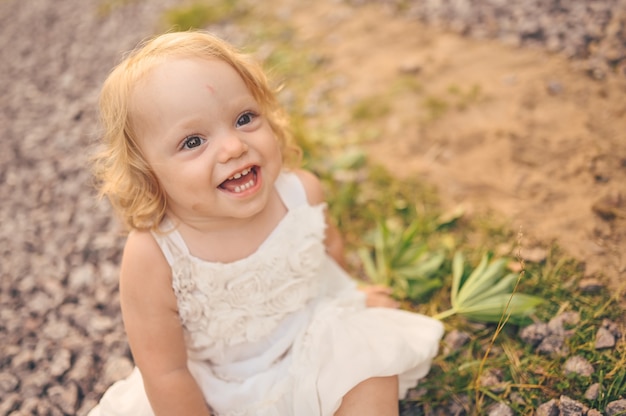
93,31,301,230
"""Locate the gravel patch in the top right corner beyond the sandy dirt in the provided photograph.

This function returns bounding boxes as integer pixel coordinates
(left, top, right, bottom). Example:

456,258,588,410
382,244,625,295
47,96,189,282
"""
358,0,626,78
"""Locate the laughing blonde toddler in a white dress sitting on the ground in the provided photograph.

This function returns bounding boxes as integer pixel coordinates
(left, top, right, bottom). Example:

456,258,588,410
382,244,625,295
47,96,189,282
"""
90,32,443,416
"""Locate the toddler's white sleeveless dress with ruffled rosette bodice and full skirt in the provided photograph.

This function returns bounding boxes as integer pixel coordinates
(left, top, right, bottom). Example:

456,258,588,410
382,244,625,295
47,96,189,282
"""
89,173,443,416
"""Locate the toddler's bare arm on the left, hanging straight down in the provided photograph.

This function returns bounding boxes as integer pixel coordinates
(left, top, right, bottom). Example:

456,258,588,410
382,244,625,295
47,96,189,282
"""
120,232,211,416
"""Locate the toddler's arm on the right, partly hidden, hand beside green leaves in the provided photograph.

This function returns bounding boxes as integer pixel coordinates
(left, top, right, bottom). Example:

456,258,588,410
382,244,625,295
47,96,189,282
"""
295,170,400,308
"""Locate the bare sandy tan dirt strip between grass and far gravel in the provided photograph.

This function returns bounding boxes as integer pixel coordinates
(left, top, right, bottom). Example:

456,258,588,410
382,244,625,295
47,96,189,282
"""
282,1,626,287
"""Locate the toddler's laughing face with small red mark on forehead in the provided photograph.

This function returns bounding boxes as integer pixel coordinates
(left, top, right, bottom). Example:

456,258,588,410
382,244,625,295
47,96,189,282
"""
131,58,282,224
